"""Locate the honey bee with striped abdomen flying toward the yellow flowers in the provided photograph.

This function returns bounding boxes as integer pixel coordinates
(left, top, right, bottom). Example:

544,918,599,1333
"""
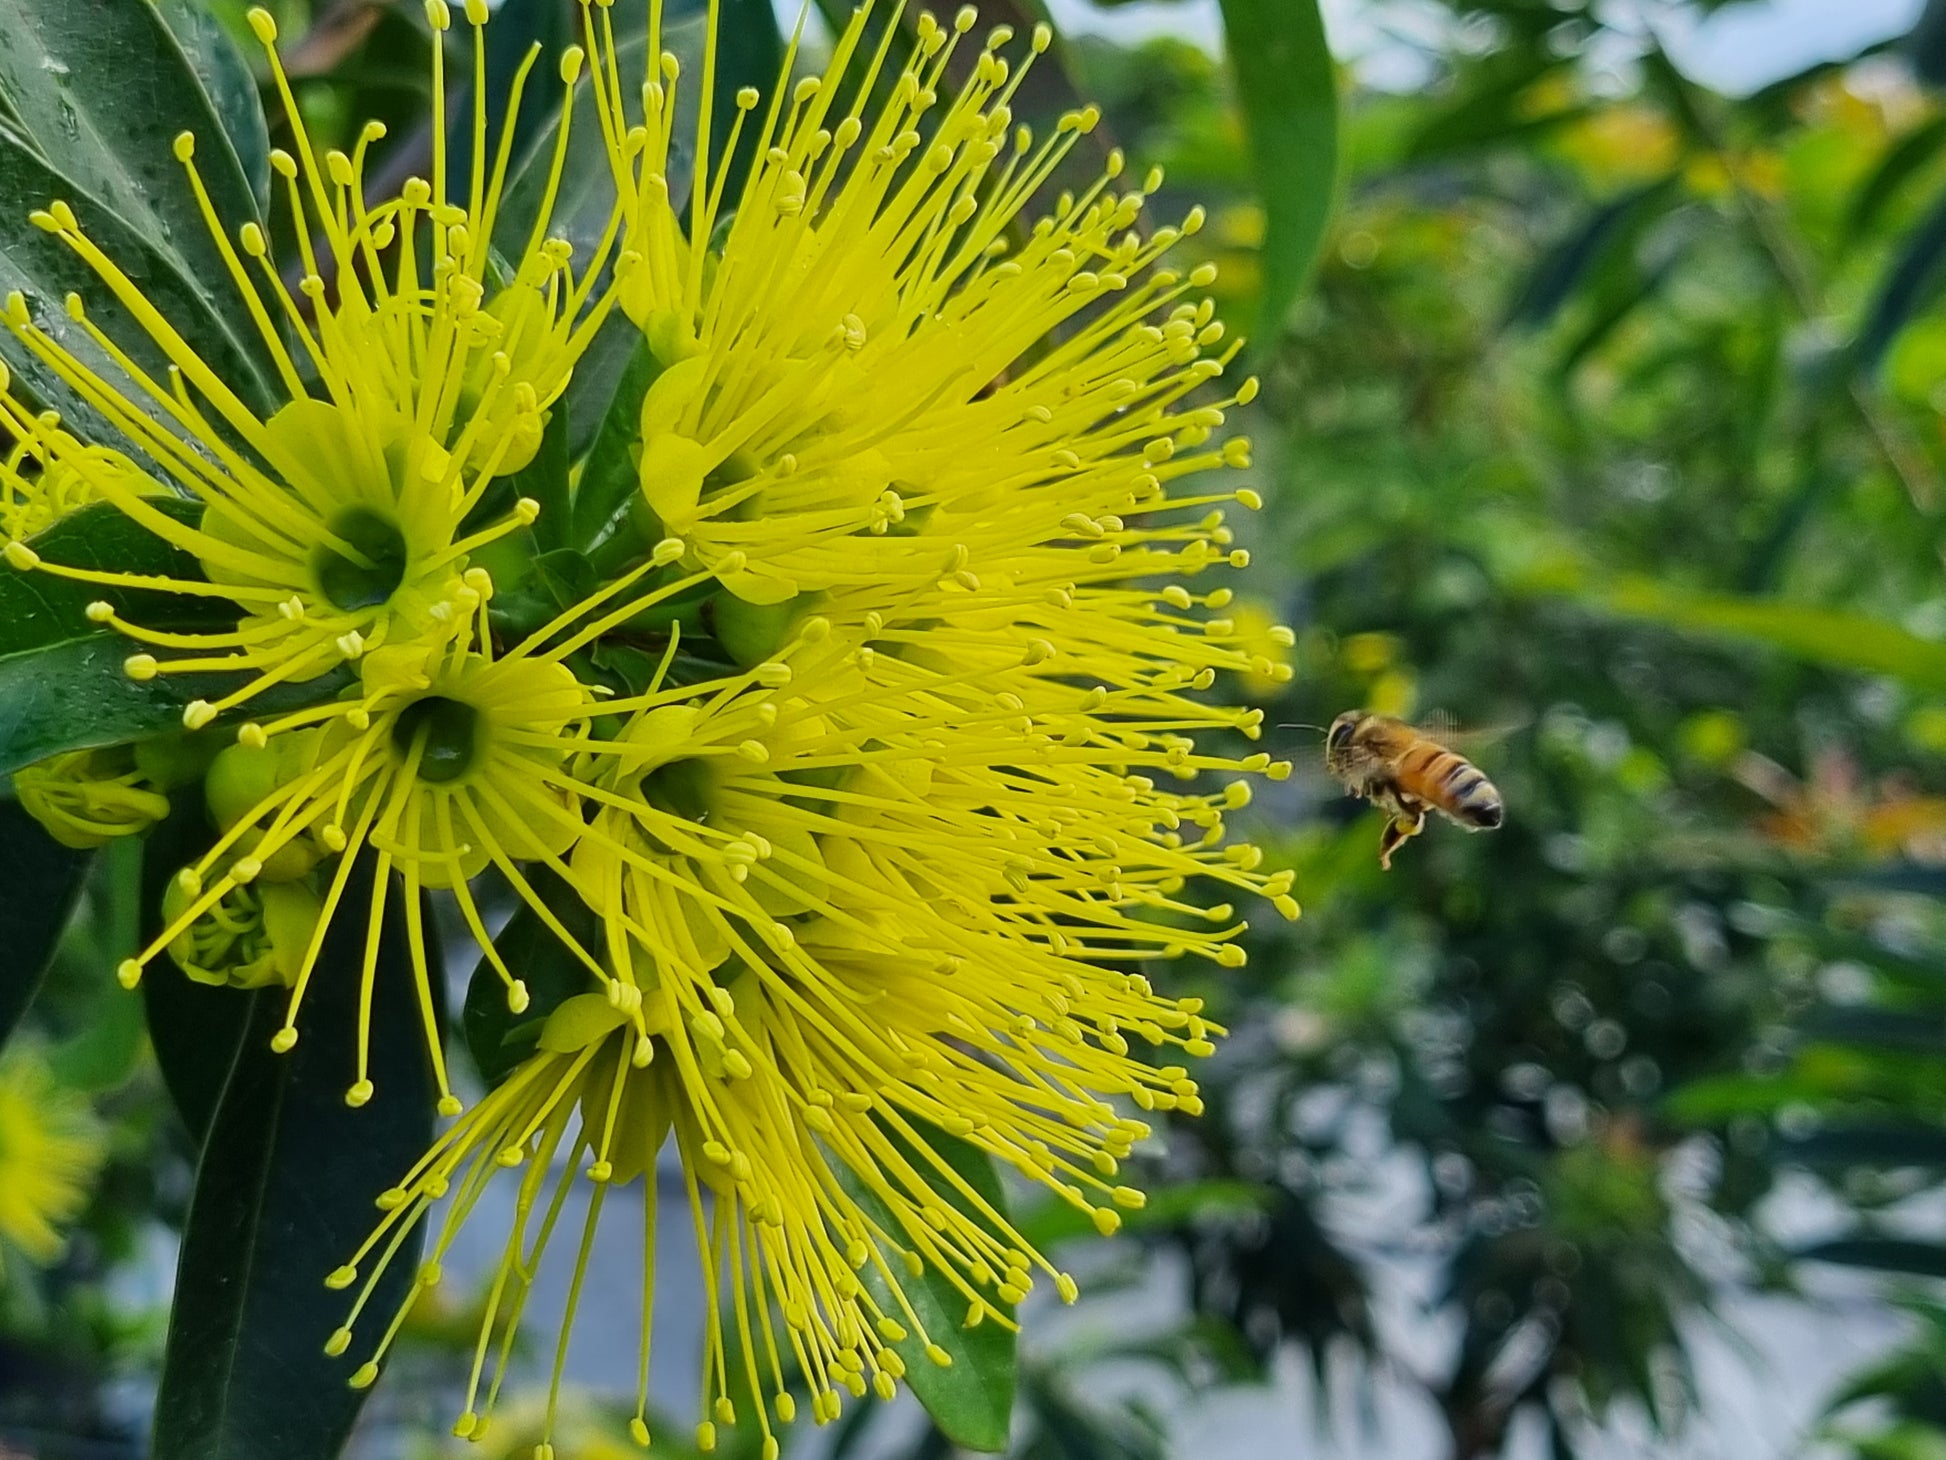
1325,711,1504,872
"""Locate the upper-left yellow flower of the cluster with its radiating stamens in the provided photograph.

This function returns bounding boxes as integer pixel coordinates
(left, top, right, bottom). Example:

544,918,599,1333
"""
4,0,617,728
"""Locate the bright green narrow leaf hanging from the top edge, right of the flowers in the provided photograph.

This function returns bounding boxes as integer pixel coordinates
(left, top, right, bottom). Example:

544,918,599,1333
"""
1222,0,1339,343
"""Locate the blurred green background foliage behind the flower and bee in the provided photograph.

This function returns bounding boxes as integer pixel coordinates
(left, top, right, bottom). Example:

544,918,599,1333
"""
11,0,1946,1460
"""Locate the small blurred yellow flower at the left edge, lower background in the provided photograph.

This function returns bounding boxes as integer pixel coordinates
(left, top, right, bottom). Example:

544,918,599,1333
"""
0,1043,107,1277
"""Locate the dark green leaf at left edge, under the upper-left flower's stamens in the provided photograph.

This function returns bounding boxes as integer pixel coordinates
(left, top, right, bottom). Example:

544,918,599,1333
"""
0,498,350,775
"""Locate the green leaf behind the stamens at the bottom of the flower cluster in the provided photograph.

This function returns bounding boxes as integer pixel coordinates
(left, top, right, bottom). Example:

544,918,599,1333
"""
839,1119,1018,1454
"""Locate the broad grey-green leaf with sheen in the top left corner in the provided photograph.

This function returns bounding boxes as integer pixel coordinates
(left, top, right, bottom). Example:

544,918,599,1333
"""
0,0,278,395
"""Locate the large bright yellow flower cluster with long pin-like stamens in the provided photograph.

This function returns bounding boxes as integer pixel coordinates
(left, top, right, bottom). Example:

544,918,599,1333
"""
0,0,1298,1456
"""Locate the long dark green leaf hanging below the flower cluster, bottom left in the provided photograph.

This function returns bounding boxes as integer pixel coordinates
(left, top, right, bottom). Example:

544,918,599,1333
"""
150,856,434,1460
